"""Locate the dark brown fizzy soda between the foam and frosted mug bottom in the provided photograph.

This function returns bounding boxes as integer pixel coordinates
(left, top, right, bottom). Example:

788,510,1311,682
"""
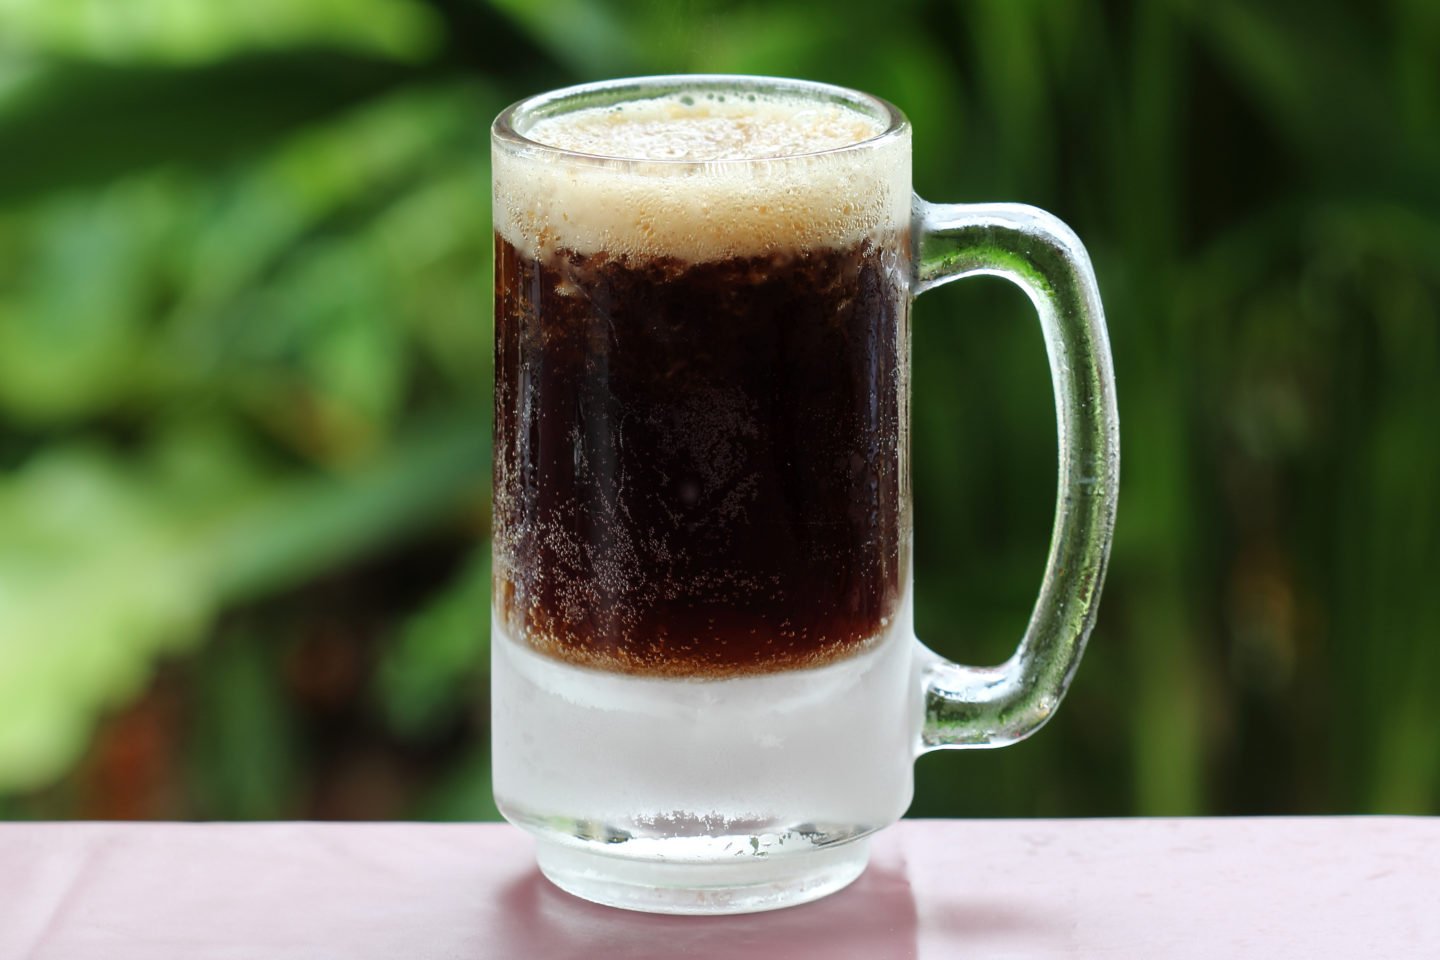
494,233,909,678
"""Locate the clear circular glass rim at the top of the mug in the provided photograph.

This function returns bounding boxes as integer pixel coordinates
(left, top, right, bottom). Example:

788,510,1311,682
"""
490,73,910,171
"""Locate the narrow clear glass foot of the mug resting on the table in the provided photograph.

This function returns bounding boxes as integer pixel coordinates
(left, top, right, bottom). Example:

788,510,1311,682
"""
536,838,870,915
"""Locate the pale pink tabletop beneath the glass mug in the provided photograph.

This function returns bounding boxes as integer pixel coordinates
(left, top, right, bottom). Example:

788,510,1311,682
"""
0,818,1440,960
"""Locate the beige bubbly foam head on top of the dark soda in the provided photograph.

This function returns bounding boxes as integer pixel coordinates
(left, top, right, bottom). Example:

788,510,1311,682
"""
494,95,910,262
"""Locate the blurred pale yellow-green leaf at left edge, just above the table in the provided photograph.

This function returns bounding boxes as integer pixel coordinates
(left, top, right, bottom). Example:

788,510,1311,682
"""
0,449,217,792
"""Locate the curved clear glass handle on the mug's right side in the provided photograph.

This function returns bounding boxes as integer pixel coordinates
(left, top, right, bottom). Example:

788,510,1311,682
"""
912,197,1120,753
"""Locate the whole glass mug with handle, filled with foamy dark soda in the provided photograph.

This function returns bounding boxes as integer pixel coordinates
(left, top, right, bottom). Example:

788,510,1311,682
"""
491,76,1119,914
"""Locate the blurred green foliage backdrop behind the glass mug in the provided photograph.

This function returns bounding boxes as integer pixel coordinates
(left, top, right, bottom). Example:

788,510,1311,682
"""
0,0,1440,819
